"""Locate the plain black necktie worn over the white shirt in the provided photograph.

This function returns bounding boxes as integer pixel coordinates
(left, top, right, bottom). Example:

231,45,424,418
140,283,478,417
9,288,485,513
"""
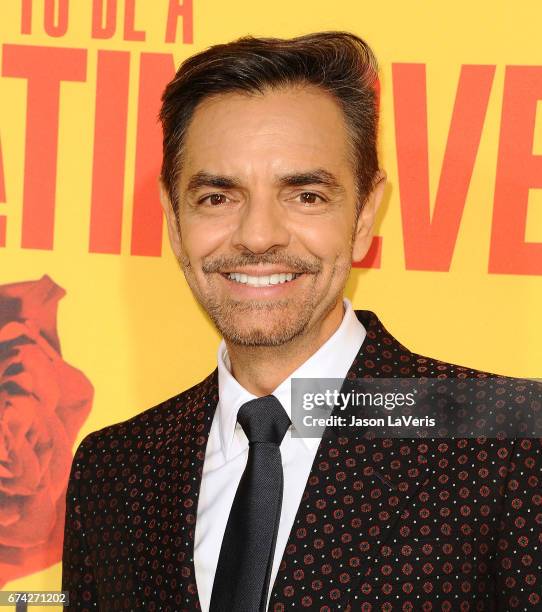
210,395,291,612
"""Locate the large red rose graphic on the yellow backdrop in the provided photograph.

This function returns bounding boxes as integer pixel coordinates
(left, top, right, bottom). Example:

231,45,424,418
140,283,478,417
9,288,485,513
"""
0,276,94,588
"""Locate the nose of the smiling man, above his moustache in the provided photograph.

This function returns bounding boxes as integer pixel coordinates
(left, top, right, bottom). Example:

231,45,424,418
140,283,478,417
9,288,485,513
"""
232,193,290,253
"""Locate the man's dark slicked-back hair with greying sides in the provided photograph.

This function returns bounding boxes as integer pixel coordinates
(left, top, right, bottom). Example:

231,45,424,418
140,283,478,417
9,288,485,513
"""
160,31,379,216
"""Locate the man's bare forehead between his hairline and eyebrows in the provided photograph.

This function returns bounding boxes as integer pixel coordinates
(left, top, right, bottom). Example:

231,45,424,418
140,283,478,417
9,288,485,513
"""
181,86,350,182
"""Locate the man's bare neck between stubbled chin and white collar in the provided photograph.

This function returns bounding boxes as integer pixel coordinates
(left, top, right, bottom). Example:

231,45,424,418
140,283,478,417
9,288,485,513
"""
226,298,343,397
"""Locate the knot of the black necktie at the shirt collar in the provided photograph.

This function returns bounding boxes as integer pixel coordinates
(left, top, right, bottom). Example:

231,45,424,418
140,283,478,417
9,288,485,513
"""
237,395,291,445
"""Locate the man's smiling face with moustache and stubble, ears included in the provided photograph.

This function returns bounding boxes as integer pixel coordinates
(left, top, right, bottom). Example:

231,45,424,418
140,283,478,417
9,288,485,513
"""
162,87,384,346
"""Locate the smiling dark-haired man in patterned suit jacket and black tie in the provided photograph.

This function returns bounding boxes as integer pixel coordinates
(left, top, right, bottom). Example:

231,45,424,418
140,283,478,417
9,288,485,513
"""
63,32,542,612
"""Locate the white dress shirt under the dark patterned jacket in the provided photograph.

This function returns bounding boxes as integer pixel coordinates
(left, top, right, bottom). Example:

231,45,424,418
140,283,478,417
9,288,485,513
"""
194,298,366,612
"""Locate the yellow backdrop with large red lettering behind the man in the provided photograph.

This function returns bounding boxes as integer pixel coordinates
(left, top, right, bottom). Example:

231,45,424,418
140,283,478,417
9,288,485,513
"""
0,0,542,609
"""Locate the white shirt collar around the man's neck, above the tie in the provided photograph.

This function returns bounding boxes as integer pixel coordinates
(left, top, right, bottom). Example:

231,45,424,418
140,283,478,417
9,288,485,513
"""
217,298,366,460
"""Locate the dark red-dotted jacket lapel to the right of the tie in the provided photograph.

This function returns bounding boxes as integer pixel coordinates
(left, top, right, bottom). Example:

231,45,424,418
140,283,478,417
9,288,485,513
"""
269,311,440,611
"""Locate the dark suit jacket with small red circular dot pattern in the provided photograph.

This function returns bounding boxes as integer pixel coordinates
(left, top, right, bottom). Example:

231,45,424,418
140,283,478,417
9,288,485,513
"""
62,311,542,612
